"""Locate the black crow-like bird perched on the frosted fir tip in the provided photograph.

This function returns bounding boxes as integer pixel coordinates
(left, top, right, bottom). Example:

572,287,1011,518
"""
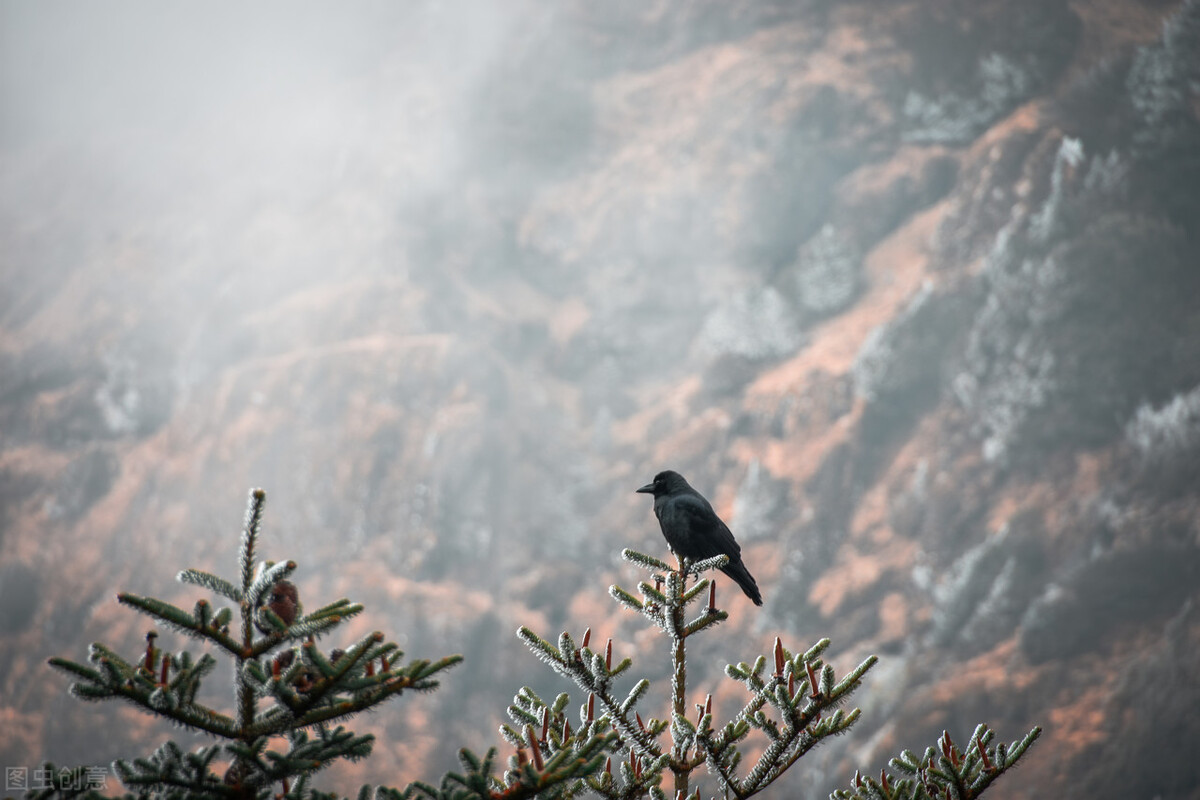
637,469,762,606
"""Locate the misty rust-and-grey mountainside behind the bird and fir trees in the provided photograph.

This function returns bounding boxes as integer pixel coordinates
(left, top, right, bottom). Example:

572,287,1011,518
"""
0,0,1200,798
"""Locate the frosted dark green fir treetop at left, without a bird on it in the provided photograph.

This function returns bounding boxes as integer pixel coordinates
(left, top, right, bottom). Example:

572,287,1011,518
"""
49,489,462,799
